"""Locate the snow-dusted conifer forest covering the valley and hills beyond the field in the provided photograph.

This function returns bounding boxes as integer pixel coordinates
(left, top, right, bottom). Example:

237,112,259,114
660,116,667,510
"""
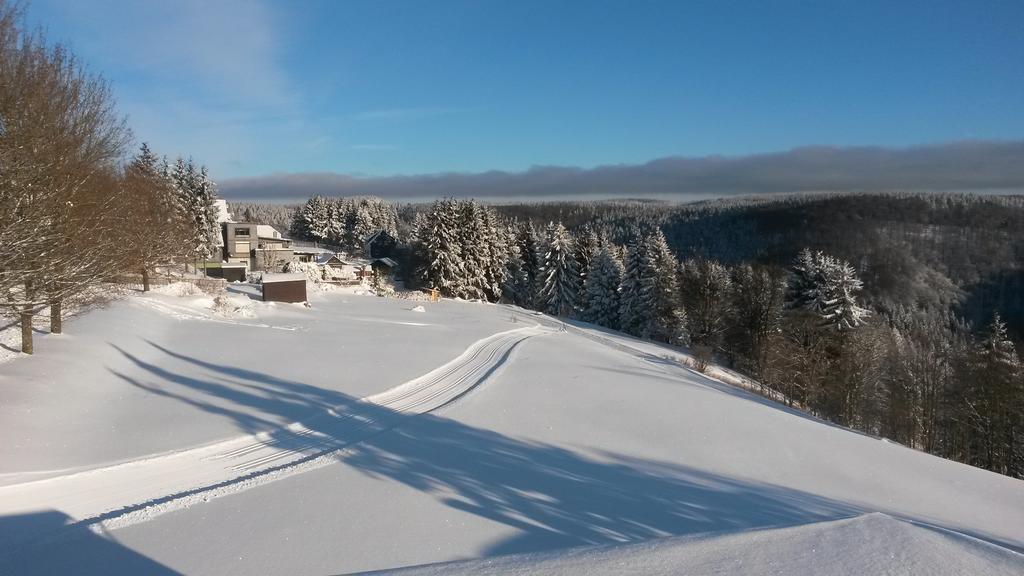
260,193,1024,478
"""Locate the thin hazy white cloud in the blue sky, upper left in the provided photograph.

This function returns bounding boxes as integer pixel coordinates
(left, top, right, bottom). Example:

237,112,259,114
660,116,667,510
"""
37,0,307,175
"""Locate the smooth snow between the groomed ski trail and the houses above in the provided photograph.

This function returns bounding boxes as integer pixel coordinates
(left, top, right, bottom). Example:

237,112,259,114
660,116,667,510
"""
0,284,513,477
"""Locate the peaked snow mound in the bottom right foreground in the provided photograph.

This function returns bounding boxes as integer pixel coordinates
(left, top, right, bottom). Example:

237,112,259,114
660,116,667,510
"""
391,512,1022,576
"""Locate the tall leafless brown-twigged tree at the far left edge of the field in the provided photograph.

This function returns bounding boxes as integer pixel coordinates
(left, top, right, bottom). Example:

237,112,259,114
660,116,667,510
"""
0,0,130,354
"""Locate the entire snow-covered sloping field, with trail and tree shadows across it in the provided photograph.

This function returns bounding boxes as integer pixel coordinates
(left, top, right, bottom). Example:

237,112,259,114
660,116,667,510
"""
0,287,1024,574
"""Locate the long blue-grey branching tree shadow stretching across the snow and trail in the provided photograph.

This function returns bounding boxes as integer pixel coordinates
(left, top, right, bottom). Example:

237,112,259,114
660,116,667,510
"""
101,342,864,556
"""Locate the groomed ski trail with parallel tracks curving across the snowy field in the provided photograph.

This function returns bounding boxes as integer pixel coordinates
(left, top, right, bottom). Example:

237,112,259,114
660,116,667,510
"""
0,325,552,541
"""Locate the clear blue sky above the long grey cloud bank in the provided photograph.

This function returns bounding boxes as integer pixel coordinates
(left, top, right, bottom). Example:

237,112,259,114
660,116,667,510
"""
29,0,1024,187
